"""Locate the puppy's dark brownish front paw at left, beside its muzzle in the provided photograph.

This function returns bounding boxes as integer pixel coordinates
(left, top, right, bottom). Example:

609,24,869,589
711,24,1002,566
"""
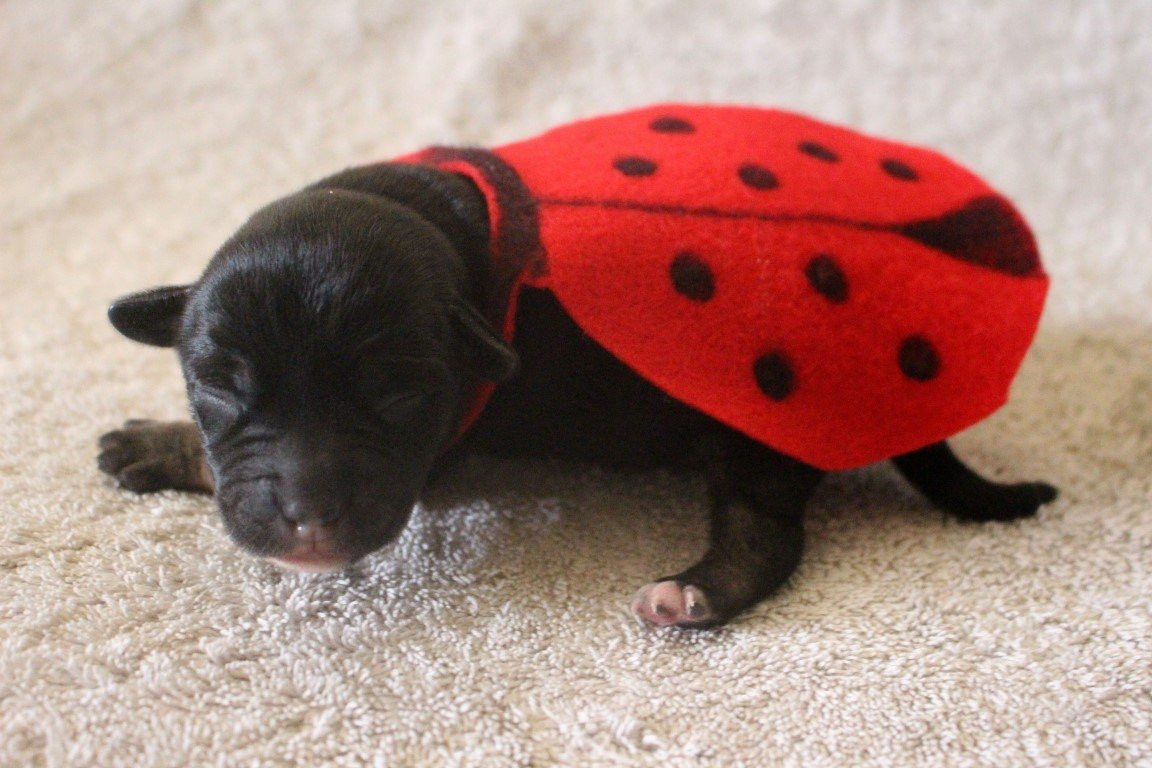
96,419,213,493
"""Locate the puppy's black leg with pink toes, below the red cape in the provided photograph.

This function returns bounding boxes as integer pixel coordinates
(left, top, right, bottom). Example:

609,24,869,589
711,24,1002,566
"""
632,436,824,628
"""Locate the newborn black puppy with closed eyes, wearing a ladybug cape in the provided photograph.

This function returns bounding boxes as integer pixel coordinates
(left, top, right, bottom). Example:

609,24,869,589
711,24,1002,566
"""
99,164,1055,626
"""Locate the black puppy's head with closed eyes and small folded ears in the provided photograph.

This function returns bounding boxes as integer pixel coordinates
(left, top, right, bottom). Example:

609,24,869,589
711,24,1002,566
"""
109,184,516,570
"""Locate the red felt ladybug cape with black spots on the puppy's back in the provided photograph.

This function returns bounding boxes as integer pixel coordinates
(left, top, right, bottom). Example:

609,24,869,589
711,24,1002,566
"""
403,105,1048,470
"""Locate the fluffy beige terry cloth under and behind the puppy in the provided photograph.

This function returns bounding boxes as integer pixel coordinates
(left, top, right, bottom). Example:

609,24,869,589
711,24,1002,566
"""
0,0,1152,768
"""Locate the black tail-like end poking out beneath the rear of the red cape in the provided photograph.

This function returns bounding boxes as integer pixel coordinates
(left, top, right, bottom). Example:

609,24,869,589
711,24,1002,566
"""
892,442,1058,520
